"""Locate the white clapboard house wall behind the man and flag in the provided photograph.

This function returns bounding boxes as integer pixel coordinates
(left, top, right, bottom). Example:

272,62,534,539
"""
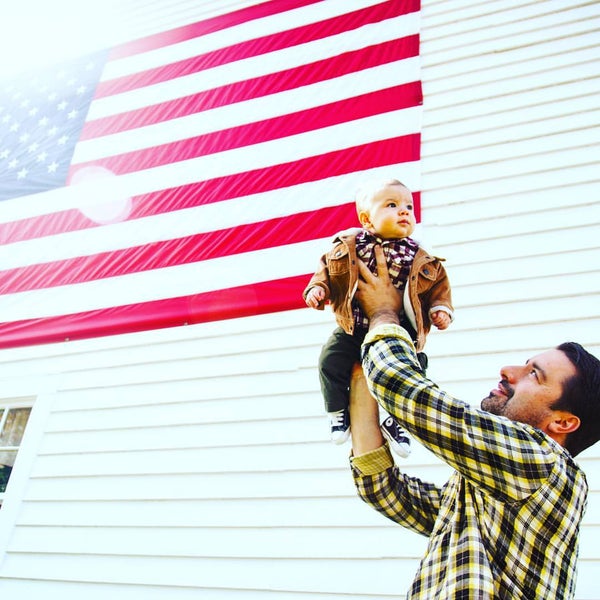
0,0,600,600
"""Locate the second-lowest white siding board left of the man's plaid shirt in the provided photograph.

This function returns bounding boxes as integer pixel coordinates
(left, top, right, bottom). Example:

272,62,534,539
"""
4,553,418,598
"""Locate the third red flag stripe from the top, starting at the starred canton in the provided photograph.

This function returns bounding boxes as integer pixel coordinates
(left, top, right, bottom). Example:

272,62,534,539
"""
81,35,419,140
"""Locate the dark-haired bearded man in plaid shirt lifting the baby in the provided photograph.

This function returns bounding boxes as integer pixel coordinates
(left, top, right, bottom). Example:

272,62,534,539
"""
350,249,600,600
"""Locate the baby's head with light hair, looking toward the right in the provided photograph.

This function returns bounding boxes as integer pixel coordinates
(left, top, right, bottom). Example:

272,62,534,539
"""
359,185,417,240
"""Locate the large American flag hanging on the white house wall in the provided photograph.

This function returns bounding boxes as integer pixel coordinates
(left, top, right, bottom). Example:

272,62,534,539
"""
0,0,422,347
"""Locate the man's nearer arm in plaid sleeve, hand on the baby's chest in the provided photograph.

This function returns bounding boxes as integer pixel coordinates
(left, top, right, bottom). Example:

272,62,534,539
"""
359,248,556,500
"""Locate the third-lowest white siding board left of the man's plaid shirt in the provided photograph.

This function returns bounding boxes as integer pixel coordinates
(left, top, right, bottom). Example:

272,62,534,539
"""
8,525,427,560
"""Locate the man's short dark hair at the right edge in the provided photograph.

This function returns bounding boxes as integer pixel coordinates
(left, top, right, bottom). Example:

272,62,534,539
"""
552,342,600,456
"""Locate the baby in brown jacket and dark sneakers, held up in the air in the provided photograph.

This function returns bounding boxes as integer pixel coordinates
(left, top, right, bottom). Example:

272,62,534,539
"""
303,179,454,457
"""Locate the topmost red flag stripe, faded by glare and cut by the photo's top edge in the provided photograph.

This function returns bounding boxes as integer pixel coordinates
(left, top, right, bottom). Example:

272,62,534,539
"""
110,0,321,60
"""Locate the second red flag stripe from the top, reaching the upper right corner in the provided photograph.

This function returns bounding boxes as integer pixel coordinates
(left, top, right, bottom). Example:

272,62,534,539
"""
95,0,419,98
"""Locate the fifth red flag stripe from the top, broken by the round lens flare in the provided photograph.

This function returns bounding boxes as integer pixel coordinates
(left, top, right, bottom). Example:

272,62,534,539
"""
7,133,421,244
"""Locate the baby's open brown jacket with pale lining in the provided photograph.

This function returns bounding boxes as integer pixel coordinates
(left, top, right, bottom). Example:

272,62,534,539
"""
302,229,454,352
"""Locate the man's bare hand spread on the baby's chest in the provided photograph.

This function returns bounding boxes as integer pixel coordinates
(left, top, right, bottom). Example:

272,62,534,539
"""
356,245,402,328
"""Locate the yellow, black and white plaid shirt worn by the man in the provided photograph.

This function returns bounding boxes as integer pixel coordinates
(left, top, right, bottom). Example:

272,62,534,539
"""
351,325,588,600
